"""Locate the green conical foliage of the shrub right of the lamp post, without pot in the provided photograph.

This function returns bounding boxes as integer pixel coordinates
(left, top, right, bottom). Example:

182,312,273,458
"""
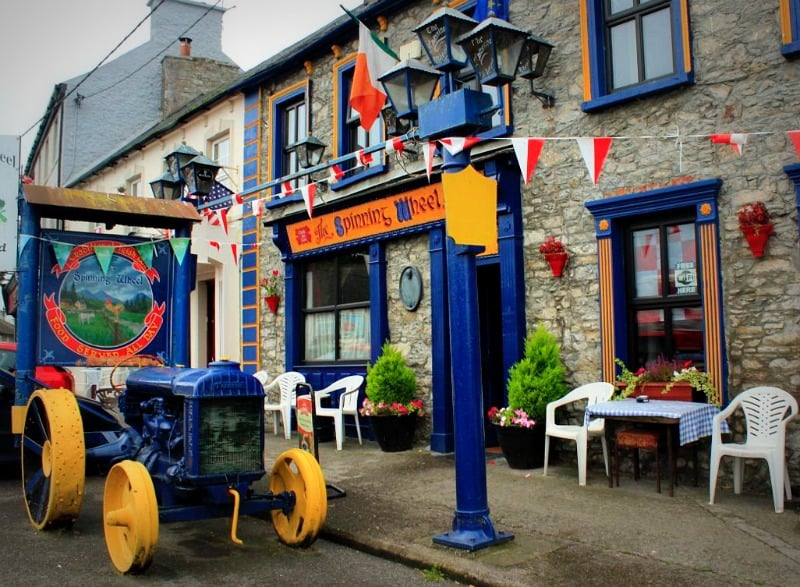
507,324,569,424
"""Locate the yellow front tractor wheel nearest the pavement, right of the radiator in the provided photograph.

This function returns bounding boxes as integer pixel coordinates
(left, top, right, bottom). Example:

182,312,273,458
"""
269,448,328,546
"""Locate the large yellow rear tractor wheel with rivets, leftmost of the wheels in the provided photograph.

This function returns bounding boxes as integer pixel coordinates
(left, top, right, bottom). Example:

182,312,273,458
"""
22,389,86,530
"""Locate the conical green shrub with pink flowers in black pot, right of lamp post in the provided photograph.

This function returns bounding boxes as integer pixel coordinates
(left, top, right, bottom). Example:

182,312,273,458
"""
488,324,569,469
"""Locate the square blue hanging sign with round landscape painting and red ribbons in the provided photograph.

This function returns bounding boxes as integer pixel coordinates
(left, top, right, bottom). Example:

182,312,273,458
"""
37,231,175,365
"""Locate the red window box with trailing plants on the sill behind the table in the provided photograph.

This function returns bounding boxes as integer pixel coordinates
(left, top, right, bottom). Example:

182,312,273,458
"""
614,355,721,406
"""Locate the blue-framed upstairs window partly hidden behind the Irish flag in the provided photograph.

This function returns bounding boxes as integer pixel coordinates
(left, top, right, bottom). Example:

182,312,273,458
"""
331,55,387,190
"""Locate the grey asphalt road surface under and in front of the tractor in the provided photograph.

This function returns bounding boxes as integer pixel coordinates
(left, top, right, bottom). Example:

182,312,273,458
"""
0,471,455,587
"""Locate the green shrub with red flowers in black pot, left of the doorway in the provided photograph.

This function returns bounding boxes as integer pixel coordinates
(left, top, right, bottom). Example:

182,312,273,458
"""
359,341,425,452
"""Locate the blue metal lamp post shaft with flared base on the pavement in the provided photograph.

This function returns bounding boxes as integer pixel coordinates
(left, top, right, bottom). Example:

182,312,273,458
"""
433,150,514,551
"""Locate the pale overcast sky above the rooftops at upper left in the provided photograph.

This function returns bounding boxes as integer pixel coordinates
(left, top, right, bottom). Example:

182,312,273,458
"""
0,0,362,166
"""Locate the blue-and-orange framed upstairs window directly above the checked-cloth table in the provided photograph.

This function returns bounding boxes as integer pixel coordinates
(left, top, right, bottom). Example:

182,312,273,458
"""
581,0,694,112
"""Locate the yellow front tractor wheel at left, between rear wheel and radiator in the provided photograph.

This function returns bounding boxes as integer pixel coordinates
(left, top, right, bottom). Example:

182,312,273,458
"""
103,461,158,573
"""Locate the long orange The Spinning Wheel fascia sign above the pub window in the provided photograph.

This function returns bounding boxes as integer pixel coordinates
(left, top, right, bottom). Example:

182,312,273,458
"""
286,183,445,253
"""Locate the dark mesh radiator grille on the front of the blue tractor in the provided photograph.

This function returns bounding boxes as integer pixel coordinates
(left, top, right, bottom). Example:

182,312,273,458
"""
198,397,264,475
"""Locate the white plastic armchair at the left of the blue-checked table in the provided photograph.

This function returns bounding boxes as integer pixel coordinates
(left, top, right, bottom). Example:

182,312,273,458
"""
544,381,614,485
